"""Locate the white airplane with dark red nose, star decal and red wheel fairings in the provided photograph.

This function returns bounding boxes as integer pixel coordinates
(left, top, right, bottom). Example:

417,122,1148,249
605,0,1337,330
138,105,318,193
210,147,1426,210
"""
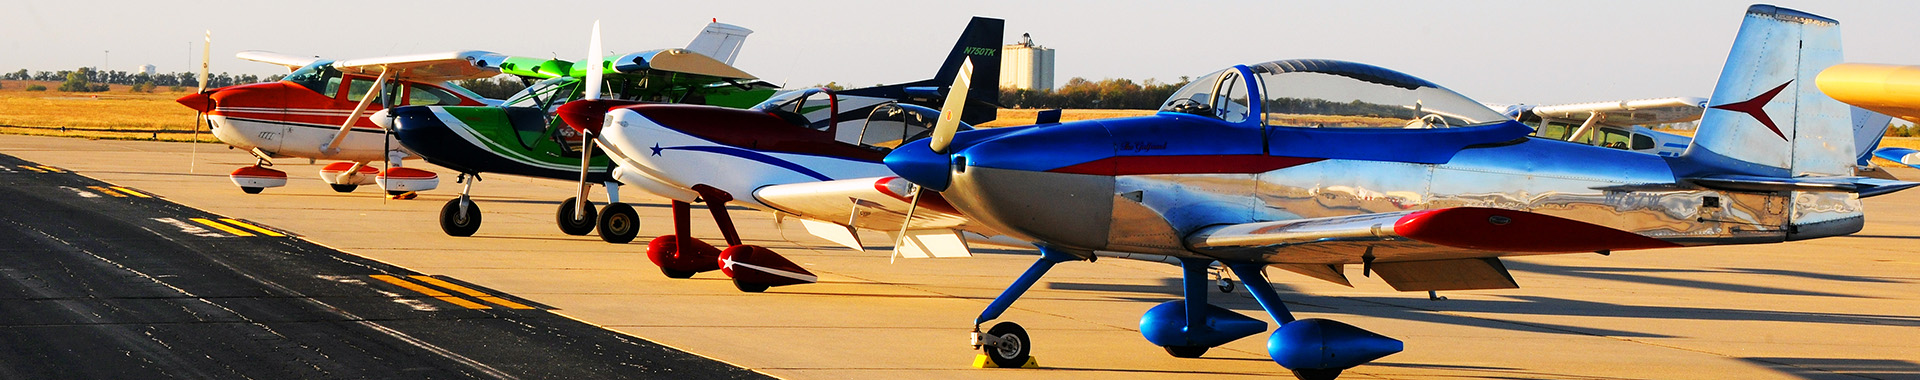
557,17,1020,292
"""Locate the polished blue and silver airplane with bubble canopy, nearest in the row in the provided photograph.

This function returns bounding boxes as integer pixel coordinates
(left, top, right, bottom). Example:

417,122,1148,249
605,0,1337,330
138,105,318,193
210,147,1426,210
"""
885,6,1920,378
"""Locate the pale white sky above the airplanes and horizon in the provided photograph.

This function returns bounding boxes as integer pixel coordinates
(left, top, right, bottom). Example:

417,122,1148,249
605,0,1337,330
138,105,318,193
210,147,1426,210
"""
0,0,1920,104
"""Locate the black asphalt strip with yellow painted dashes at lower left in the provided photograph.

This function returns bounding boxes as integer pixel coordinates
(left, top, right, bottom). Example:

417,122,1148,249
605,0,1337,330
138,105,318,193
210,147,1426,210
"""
0,155,764,378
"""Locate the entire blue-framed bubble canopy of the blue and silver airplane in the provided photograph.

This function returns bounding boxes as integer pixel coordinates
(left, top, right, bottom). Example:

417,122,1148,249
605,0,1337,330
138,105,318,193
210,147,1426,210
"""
1160,59,1509,129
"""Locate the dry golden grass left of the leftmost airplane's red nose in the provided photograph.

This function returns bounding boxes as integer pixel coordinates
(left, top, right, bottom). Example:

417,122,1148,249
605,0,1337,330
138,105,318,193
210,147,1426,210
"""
0,81,213,142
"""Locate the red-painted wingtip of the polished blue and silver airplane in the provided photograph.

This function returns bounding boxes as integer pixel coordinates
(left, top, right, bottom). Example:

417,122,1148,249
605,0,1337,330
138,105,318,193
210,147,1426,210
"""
1394,207,1680,253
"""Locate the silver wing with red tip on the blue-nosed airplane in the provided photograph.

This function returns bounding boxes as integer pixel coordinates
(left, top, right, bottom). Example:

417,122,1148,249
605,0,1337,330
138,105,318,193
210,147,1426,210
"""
1187,207,1676,292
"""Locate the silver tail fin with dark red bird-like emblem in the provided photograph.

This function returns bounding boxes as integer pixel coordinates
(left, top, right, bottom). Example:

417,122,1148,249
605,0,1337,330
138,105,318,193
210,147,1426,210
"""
1682,6,1857,177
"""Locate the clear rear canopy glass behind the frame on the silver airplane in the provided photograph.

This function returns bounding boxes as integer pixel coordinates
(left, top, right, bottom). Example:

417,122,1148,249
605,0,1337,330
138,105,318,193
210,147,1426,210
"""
1254,59,1509,129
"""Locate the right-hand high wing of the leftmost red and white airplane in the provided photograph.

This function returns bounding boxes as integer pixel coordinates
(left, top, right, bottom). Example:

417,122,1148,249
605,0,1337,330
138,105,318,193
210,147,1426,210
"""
334,50,507,83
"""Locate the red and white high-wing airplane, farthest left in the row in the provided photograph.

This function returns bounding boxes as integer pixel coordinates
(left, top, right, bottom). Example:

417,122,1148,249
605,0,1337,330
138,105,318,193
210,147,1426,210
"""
179,50,507,194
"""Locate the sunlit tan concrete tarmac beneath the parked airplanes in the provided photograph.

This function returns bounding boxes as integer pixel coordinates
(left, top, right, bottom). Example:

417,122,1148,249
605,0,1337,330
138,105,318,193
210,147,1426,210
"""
0,136,1920,380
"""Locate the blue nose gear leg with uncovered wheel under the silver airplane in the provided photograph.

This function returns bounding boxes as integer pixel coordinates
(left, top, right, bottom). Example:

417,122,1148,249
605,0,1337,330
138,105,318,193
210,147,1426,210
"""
973,246,1081,368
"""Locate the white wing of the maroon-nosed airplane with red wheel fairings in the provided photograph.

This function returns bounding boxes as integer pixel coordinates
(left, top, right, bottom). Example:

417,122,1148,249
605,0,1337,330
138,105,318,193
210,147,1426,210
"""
753,177,1006,257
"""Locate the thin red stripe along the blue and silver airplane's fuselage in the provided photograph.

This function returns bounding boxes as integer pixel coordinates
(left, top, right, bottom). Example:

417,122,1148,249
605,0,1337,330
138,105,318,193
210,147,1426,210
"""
1050,154,1321,175
